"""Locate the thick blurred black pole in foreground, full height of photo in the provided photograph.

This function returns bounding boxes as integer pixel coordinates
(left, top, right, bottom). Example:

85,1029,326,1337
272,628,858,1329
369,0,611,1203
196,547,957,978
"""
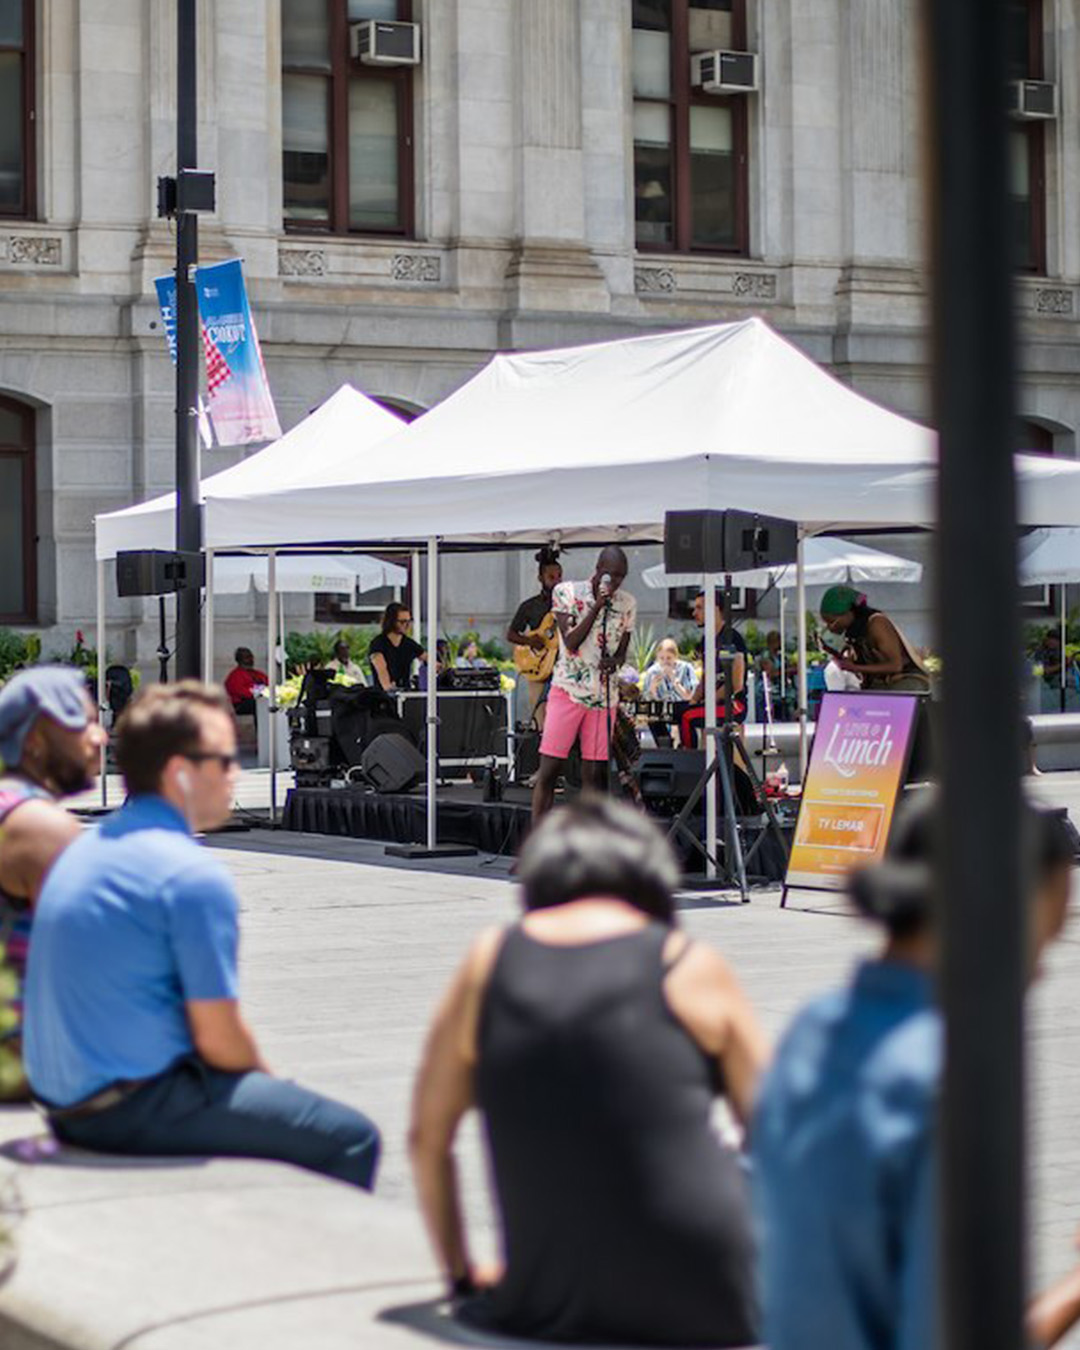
923,0,1026,1350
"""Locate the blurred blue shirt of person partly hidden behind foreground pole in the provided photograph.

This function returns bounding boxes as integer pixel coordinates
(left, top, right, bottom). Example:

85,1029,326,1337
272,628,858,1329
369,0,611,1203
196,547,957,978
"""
752,961,942,1350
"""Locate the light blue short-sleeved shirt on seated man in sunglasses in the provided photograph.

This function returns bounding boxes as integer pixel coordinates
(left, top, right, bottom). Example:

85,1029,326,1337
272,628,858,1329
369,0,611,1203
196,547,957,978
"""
23,797,238,1106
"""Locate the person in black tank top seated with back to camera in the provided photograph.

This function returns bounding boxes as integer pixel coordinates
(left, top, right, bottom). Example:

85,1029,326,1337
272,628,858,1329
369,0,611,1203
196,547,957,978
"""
410,798,764,1346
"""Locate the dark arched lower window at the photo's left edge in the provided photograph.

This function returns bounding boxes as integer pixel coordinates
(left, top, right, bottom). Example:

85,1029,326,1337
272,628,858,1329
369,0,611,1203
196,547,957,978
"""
0,398,38,624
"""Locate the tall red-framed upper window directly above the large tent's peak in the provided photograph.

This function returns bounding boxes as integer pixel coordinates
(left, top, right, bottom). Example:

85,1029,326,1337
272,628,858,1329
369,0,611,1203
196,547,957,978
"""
633,0,749,254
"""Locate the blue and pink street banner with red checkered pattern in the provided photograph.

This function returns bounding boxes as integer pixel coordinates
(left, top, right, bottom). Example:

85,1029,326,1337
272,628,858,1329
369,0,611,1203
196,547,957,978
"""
193,258,281,446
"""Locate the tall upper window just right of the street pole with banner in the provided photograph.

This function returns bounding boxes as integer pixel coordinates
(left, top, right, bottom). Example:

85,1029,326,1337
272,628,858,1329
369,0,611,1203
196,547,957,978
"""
281,0,413,235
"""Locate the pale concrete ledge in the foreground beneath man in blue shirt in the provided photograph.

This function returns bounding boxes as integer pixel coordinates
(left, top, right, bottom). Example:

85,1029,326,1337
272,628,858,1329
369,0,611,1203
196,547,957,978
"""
0,1110,443,1350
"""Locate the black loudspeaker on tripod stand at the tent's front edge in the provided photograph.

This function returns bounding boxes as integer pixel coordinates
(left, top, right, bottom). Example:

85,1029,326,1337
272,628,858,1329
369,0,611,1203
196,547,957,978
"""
664,510,798,574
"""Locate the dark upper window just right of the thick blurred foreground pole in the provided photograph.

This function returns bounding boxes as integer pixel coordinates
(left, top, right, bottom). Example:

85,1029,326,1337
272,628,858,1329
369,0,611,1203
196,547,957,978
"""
1008,0,1046,273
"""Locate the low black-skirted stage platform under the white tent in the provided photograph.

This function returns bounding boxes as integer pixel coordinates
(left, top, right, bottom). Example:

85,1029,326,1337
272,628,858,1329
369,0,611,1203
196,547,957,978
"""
281,783,791,882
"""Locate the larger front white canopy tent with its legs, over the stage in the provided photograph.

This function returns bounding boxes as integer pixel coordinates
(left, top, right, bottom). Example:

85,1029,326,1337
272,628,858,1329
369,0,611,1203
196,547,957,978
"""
191,319,1080,852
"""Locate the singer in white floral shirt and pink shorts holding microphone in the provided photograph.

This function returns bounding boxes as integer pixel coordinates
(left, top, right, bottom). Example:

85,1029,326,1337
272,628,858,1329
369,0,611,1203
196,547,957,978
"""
532,544,637,821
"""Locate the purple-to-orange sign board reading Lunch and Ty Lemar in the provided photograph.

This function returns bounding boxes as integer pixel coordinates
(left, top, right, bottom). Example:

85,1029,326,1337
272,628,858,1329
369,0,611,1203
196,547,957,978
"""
786,693,919,891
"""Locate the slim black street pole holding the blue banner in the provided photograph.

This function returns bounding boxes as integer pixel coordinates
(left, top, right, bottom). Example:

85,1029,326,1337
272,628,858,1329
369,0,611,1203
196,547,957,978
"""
176,0,203,679
